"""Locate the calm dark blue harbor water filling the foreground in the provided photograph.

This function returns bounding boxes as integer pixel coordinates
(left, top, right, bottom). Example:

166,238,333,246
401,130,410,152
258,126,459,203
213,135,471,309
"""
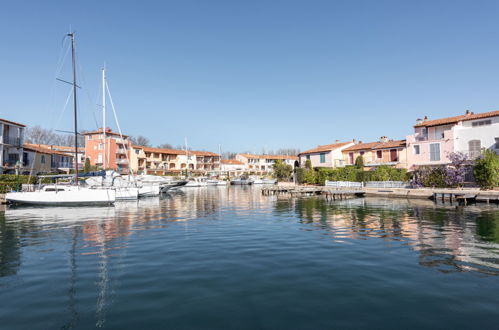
0,187,499,329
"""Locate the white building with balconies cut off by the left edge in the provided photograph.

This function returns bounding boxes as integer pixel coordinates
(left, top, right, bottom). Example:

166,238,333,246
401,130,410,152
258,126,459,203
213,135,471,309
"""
0,118,26,174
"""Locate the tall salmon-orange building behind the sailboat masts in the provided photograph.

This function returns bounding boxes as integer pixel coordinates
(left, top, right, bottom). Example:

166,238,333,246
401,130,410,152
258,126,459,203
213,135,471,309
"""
84,128,132,173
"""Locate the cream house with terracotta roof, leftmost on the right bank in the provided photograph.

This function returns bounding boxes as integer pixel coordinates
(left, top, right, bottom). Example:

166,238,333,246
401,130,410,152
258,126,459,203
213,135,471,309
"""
298,140,355,168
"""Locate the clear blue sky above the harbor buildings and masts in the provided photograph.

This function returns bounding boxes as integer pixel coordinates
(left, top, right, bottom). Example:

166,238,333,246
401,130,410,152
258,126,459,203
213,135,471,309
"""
0,0,499,152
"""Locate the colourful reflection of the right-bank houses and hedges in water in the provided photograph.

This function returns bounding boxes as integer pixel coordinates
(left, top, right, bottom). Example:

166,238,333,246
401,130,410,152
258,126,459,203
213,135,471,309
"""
288,198,499,275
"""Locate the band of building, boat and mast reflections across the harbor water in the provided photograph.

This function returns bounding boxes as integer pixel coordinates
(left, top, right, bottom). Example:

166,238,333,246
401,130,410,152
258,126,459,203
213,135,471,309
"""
0,187,499,328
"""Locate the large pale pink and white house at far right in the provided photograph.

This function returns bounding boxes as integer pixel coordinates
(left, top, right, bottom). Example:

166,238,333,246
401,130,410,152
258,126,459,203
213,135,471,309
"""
407,110,499,169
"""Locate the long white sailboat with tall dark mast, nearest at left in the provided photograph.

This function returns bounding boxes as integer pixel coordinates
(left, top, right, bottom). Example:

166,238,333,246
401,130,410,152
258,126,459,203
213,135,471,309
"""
5,32,116,205
